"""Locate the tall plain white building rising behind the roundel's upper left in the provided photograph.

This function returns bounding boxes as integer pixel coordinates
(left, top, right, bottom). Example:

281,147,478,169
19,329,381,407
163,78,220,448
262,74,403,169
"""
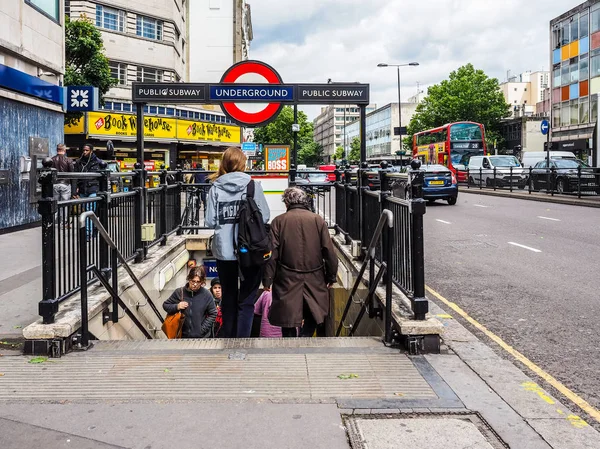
189,0,254,83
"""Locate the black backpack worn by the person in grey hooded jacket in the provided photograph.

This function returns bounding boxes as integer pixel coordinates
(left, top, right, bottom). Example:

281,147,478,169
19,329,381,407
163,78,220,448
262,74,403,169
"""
233,180,271,268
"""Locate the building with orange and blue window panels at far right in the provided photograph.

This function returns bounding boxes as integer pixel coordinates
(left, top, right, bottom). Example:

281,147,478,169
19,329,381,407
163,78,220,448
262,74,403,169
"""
550,0,600,165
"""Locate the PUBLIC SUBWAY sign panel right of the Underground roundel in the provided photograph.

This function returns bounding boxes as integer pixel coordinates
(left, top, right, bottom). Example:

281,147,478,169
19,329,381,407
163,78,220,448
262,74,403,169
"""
296,83,369,104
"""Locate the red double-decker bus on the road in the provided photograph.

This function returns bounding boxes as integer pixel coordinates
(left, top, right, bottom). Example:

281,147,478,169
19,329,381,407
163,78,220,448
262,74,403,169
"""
413,122,487,182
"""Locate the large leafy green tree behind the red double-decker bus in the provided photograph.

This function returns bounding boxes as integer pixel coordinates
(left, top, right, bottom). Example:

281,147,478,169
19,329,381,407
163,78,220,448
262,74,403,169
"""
403,64,510,148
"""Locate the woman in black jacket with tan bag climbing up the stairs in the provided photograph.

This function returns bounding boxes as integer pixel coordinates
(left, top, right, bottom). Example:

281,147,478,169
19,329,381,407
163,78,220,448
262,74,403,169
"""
163,266,217,338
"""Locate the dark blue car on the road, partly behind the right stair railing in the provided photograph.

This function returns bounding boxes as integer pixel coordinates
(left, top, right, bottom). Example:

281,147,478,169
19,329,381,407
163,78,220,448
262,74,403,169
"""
391,164,458,206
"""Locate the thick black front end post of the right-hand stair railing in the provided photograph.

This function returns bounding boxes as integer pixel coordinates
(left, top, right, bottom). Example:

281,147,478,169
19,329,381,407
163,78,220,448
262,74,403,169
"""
411,166,429,321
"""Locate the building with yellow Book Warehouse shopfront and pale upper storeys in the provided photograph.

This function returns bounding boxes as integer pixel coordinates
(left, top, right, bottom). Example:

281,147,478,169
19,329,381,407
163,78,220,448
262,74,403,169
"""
65,0,241,170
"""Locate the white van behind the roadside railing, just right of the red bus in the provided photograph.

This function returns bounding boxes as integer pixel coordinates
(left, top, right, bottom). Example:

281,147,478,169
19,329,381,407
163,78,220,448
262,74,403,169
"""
469,155,528,189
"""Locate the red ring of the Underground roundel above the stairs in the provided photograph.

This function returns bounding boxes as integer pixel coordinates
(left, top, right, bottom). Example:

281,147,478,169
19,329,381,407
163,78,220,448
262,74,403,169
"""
221,60,293,126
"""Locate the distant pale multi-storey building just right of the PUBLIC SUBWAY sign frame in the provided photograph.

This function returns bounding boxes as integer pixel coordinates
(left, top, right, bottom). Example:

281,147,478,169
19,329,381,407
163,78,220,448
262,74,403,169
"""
313,105,377,162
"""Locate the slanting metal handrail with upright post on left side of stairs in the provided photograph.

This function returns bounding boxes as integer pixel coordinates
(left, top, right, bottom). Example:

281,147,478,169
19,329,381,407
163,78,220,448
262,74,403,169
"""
79,211,164,347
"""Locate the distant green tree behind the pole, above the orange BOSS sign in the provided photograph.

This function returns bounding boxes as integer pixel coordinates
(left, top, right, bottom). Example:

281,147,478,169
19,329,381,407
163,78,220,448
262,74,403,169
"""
254,106,313,147
